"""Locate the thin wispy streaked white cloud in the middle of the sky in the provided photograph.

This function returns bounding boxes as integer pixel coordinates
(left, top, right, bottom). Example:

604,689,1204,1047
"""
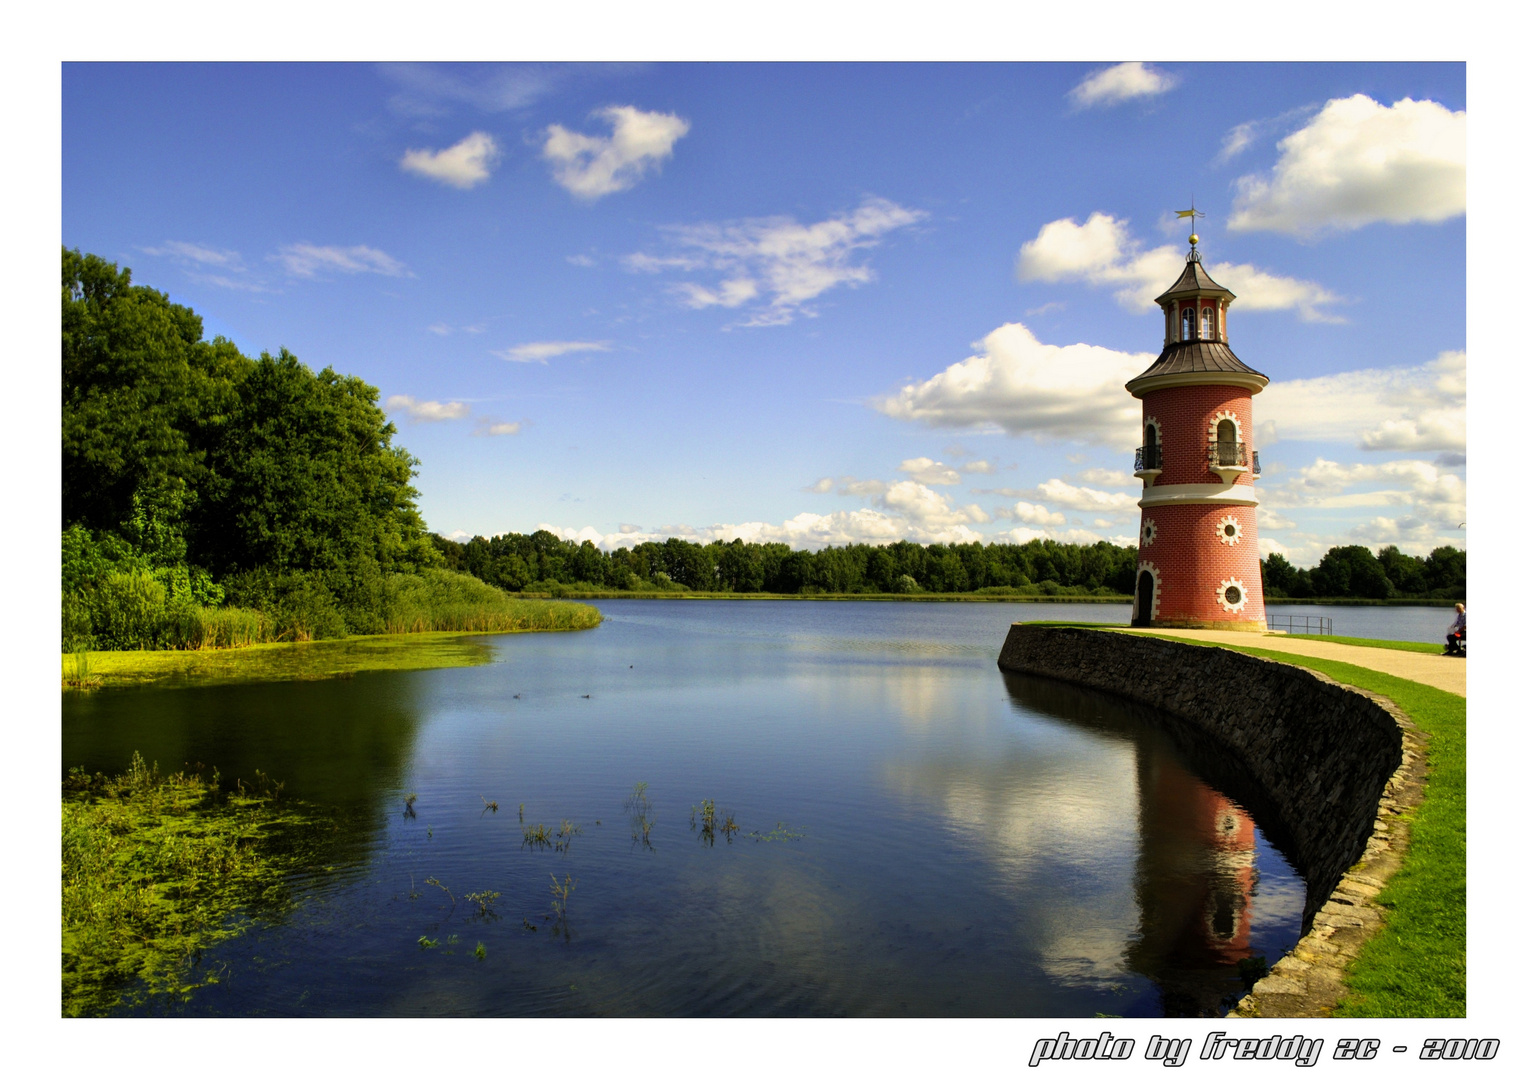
625,197,926,325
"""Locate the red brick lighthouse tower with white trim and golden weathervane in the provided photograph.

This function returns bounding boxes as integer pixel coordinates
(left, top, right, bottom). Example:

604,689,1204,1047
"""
1125,235,1268,629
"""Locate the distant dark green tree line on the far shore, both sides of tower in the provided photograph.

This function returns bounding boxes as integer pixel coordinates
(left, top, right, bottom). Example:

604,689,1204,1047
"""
431,530,1464,599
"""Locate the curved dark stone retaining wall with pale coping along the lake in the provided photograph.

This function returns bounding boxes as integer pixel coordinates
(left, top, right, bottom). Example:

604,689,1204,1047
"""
998,623,1424,1016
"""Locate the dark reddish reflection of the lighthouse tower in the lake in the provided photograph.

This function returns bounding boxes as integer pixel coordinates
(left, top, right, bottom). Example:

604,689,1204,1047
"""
1126,745,1258,1016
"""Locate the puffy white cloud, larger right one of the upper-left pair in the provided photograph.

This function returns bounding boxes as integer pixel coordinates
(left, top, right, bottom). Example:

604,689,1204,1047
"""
541,105,689,200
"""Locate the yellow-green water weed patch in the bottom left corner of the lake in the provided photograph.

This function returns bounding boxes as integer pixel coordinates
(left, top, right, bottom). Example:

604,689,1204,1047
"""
63,753,330,1016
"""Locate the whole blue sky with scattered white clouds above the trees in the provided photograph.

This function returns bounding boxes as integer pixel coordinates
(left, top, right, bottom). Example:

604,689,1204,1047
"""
63,63,1465,565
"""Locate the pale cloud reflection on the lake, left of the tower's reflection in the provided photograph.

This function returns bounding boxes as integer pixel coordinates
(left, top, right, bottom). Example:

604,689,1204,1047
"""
886,723,1140,984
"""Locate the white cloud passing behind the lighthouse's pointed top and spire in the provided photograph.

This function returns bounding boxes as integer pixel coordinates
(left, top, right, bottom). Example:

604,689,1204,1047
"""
1016,211,1340,321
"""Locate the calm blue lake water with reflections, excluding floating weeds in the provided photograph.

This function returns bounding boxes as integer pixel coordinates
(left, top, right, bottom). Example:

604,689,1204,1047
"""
53,600,1307,1017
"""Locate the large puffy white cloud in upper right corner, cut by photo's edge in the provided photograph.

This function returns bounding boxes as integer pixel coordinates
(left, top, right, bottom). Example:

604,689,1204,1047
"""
1229,93,1465,237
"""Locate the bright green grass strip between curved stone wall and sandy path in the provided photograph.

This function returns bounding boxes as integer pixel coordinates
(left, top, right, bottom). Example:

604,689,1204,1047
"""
1136,639,1465,1016
